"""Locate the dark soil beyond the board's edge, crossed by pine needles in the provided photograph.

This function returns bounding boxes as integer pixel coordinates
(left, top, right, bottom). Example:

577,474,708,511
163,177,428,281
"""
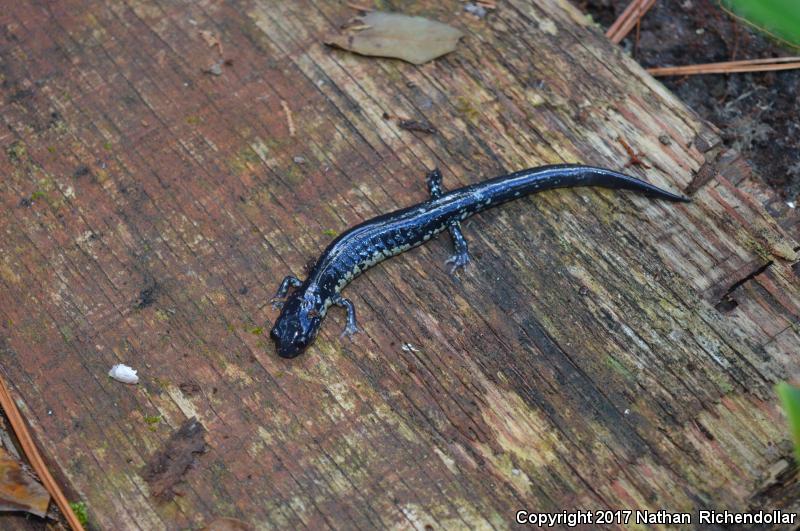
573,0,800,201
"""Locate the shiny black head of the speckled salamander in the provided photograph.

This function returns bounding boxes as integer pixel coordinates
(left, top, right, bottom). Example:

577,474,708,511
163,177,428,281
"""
269,291,323,358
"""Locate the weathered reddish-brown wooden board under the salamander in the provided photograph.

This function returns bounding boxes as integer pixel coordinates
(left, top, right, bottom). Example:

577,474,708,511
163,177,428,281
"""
0,0,800,529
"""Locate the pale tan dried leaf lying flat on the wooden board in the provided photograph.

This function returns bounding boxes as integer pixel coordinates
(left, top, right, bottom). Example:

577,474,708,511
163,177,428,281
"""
325,11,463,65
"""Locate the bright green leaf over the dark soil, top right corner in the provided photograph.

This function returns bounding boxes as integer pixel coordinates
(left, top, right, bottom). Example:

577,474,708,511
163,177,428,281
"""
722,0,800,46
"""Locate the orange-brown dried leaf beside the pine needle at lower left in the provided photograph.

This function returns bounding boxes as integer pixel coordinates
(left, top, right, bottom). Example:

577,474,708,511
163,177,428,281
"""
0,448,50,518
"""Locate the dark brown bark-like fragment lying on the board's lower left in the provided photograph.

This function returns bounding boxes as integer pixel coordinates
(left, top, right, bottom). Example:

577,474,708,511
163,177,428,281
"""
142,417,207,500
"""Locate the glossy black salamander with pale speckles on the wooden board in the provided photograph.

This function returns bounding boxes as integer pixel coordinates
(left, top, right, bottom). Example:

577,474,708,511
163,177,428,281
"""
270,164,689,358
